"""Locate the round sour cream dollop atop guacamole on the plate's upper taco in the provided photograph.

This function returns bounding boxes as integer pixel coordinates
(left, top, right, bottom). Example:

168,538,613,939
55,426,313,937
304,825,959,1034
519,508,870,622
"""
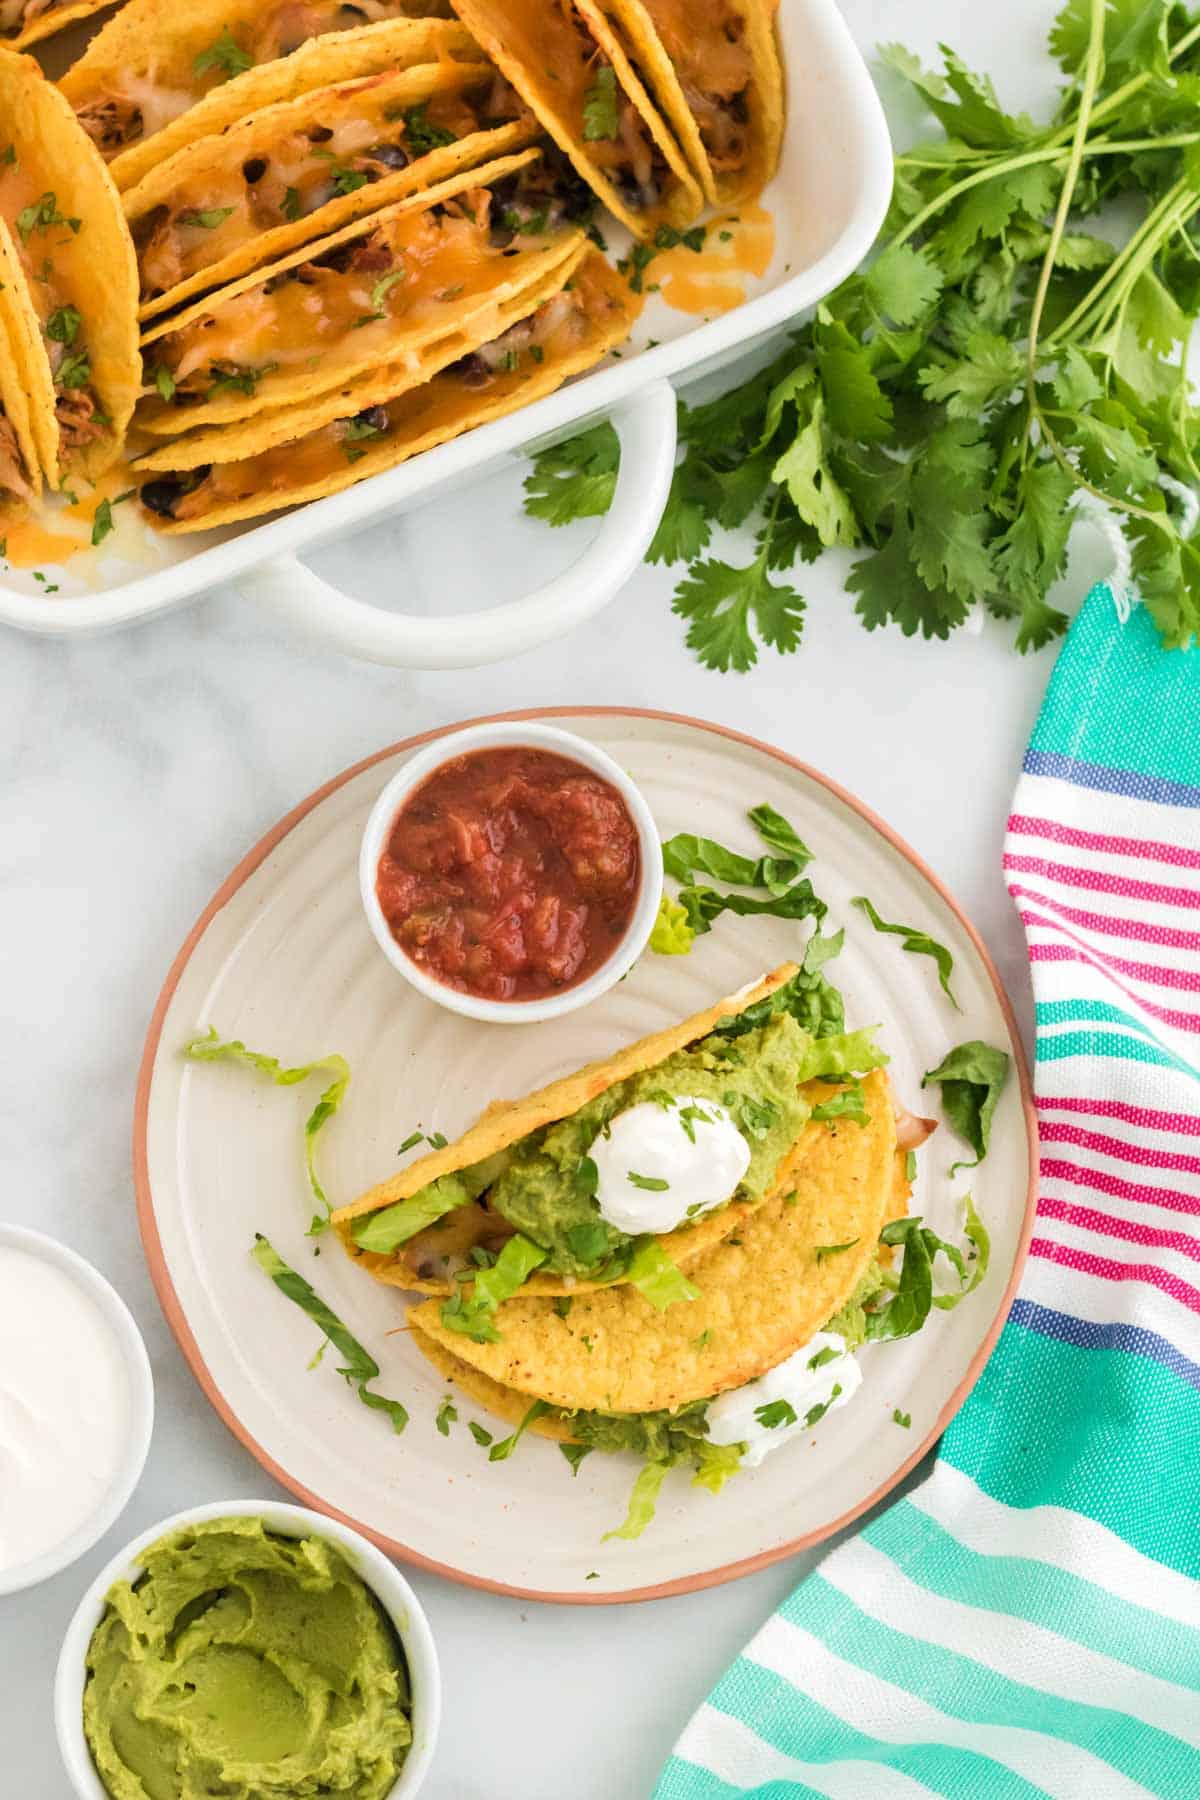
588,1094,750,1237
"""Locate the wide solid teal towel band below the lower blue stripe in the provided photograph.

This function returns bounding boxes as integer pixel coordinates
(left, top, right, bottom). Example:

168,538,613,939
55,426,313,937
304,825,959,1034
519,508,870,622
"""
941,1321,1200,1576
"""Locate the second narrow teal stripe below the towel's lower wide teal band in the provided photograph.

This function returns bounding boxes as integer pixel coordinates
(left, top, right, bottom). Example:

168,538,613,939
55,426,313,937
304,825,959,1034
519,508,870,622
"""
781,1573,1200,1800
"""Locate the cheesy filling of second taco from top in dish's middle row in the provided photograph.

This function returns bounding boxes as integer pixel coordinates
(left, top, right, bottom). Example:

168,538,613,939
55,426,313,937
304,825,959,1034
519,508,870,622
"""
133,76,524,301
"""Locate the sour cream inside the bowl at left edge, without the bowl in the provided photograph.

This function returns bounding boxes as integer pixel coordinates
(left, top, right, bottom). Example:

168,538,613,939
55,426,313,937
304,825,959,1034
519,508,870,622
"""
0,1246,133,1570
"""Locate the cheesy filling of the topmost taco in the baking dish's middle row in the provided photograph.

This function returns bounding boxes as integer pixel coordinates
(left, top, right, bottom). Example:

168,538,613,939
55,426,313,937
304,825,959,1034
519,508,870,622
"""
76,0,443,157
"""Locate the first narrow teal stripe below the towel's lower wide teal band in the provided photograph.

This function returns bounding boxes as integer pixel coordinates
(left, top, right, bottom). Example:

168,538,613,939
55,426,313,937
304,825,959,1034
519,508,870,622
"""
862,1499,1200,1706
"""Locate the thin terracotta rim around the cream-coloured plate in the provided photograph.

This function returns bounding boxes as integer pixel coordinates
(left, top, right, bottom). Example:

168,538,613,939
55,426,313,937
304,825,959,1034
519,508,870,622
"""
133,706,1038,1606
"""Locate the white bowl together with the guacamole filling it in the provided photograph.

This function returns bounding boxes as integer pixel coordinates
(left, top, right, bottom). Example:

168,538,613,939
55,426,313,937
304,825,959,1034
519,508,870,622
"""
54,1499,441,1800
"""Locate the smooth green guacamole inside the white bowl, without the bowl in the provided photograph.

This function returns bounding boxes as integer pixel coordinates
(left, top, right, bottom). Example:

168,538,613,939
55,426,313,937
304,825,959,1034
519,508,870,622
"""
83,1517,412,1800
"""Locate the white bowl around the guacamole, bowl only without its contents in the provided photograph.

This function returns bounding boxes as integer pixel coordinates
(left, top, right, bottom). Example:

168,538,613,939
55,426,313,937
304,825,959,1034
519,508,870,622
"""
54,1499,441,1800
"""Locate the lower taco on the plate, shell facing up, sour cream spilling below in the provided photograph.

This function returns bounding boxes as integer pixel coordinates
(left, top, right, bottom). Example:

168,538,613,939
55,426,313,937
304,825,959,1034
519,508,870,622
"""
407,1073,928,1537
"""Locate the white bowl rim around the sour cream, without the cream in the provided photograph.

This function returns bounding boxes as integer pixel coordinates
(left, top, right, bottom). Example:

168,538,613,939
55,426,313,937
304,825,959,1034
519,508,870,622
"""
0,1224,155,1595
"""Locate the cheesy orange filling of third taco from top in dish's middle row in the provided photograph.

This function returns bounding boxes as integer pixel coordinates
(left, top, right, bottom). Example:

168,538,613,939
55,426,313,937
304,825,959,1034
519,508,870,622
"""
148,164,578,414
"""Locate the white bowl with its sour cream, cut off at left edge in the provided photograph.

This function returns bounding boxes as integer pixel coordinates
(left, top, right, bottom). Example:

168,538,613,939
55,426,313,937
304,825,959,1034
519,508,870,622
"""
0,1224,155,1595
